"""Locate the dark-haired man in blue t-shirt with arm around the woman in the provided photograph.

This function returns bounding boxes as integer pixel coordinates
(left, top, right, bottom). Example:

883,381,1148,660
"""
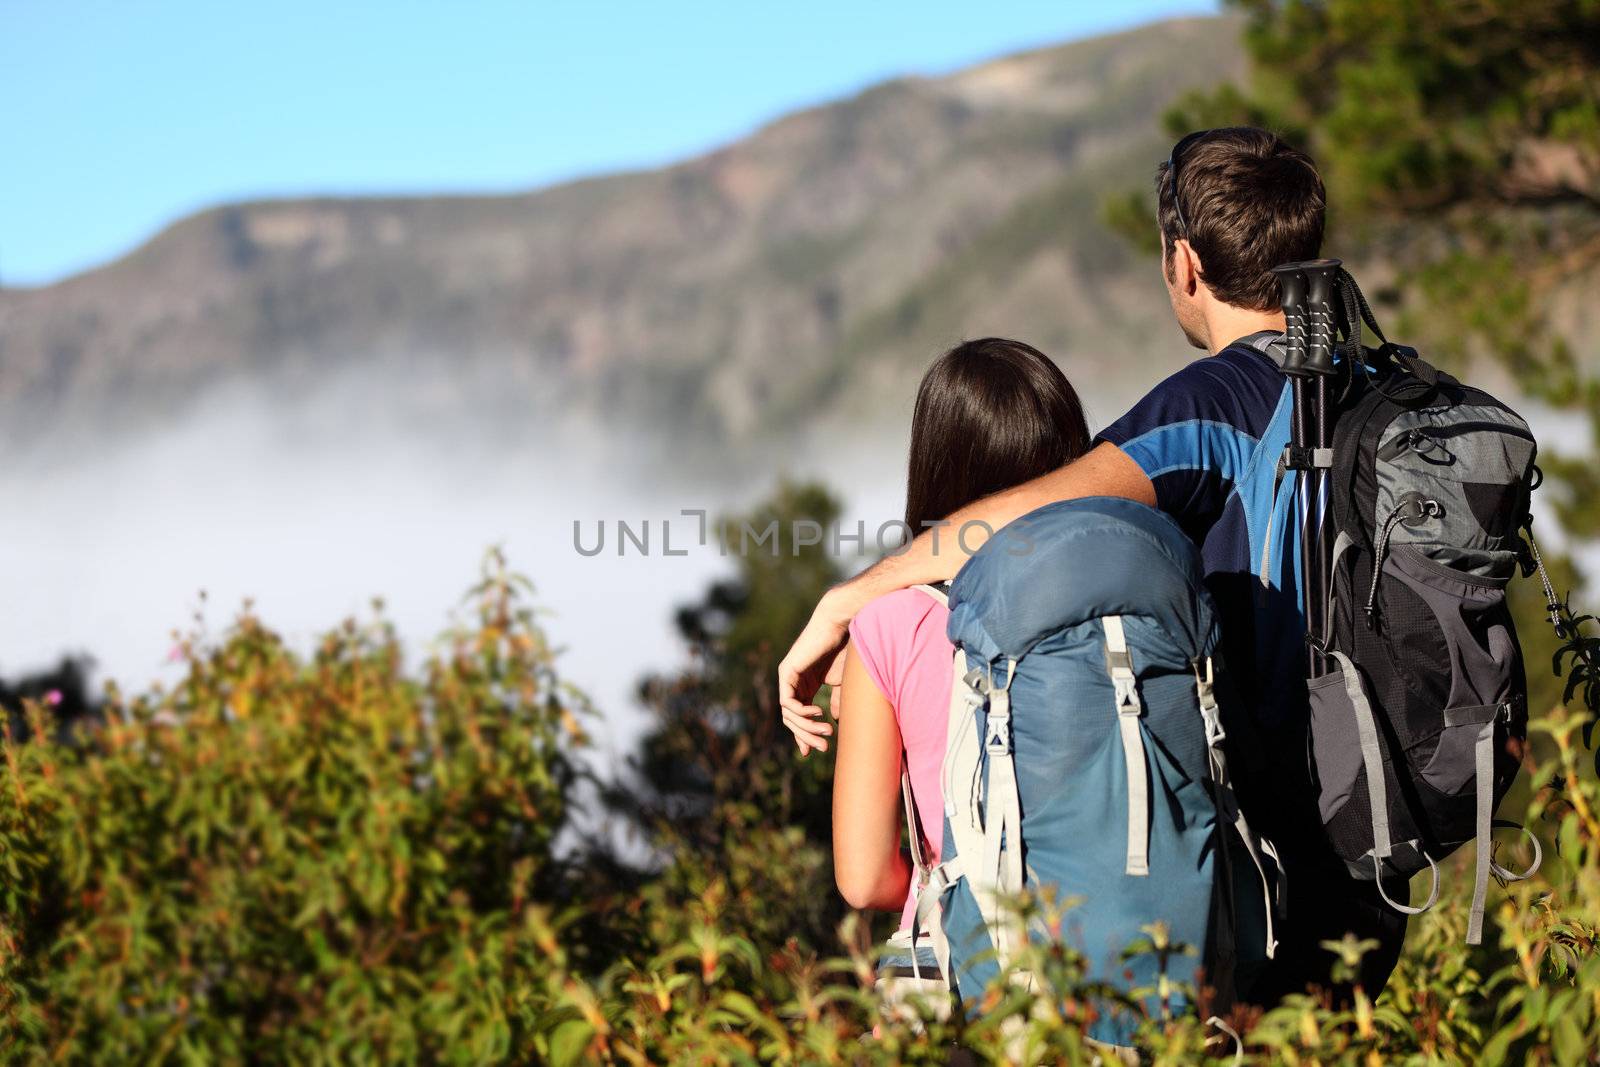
778,128,1405,1005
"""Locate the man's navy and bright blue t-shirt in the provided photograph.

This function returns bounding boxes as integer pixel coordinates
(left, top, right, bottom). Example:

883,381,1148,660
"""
1096,333,1306,729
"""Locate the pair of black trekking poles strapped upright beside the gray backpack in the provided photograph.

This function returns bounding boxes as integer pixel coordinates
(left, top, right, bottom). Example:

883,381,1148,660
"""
1274,259,1341,678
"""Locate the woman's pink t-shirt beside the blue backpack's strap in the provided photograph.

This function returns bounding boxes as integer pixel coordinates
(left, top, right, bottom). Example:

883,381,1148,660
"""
845,589,955,928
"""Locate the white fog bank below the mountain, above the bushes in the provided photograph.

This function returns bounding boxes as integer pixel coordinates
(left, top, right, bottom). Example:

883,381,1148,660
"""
0,383,901,763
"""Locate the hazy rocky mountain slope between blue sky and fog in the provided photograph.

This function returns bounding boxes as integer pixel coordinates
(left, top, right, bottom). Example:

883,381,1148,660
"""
0,19,1243,453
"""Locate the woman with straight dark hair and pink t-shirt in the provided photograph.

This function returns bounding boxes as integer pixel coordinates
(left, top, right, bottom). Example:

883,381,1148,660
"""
834,338,1090,976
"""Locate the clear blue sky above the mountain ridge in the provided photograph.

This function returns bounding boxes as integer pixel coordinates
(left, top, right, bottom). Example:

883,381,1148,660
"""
0,0,1216,285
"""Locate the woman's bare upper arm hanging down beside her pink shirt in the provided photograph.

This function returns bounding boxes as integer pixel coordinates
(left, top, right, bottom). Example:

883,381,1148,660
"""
834,651,910,910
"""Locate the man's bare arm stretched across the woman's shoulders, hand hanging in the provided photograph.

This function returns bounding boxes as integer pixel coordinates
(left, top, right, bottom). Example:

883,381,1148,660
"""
778,443,1155,755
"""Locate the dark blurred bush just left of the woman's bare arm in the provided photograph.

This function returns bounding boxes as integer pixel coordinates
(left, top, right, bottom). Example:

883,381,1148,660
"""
613,482,843,944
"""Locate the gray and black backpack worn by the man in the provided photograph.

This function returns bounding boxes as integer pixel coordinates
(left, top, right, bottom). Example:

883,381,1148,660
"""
1309,331,1539,944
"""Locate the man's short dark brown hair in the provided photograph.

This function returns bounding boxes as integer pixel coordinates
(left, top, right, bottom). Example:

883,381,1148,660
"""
1155,126,1326,310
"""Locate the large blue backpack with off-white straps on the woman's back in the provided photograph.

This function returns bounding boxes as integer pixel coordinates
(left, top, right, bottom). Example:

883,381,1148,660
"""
907,498,1282,1045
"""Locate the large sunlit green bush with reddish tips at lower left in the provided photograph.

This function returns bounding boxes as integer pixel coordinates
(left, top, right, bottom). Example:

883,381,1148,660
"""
0,557,582,1062
